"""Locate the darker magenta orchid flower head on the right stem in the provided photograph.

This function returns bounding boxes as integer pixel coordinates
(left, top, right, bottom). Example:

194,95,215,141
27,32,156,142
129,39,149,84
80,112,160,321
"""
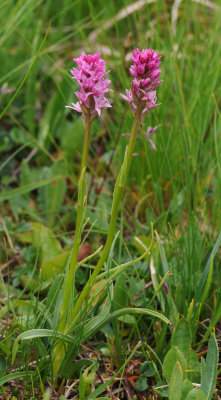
121,49,162,118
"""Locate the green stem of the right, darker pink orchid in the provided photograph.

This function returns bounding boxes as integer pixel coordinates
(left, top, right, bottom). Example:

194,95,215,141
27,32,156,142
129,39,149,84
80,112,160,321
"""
70,110,142,321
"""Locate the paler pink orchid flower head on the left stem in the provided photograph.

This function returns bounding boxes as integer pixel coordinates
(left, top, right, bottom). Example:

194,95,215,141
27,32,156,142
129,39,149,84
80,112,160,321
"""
66,51,111,119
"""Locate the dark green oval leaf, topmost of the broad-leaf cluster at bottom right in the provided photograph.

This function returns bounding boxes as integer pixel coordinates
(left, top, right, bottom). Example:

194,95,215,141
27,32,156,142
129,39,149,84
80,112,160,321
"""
171,318,192,355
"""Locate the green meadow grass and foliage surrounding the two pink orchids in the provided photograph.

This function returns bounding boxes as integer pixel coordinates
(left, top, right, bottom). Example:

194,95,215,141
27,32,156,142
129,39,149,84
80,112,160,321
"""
0,0,221,399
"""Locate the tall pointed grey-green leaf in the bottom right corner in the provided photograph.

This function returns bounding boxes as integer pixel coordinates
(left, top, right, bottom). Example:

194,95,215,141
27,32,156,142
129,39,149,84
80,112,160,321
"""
201,334,219,400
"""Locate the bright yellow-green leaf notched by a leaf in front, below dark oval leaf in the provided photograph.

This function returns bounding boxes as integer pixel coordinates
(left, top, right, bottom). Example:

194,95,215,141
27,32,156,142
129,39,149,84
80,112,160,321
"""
163,346,187,383
